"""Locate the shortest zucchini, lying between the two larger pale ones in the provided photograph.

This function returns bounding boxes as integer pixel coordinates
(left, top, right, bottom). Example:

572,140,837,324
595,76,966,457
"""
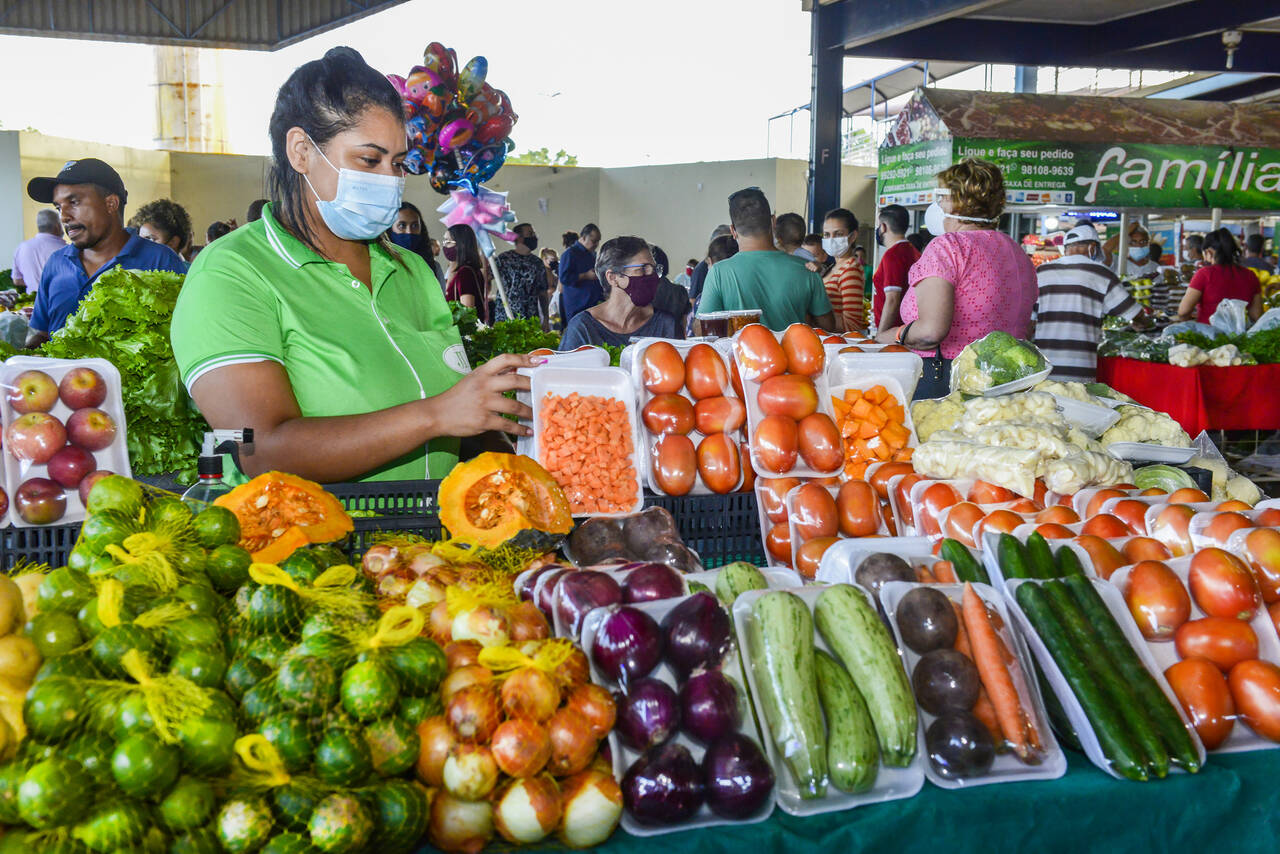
814,649,879,794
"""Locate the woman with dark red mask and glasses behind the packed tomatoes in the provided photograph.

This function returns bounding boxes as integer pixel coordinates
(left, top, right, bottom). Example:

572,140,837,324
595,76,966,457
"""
559,237,677,351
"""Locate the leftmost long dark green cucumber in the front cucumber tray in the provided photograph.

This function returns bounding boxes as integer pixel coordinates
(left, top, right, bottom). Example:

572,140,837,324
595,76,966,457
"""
1015,584,1147,781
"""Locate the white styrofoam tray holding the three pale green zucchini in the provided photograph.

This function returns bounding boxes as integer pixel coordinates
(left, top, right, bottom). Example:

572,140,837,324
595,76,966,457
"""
733,585,924,816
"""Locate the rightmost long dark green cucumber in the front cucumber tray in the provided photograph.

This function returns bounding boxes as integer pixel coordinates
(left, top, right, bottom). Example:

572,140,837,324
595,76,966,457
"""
1064,573,1201,773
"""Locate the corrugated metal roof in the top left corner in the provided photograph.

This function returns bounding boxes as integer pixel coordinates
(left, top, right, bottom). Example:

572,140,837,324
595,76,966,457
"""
0,0,404,50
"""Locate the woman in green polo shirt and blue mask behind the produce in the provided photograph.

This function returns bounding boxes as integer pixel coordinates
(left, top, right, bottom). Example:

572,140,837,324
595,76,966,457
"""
170,47,535,483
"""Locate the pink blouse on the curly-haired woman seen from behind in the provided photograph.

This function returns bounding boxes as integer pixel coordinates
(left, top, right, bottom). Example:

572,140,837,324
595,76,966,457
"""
901,229,1037,359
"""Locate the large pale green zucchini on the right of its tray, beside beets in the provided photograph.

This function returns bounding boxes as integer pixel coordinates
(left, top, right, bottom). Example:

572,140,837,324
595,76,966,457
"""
813,584,918,767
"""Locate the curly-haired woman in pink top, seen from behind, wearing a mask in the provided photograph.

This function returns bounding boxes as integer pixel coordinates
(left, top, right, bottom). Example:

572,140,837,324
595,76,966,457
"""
877,157,1037,399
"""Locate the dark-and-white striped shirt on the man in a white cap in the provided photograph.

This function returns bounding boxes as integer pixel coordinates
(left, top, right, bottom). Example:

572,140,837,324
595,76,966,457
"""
1036,255,1142,382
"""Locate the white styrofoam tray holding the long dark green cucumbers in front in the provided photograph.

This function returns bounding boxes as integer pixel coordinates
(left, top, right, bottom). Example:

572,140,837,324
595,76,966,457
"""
1005,579,1204,780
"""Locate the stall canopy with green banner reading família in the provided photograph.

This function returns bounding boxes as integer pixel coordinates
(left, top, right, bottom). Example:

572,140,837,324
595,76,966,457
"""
877,88,1280,211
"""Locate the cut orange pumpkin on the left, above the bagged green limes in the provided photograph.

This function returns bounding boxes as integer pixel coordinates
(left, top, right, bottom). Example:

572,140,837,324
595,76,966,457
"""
214,471,355,563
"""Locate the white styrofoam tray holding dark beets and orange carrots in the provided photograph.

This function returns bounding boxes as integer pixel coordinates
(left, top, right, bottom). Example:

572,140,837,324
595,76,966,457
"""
881,581,1066,789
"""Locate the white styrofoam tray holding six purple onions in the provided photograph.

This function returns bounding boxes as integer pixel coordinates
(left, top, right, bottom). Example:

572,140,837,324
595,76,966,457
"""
582,594,782,836
